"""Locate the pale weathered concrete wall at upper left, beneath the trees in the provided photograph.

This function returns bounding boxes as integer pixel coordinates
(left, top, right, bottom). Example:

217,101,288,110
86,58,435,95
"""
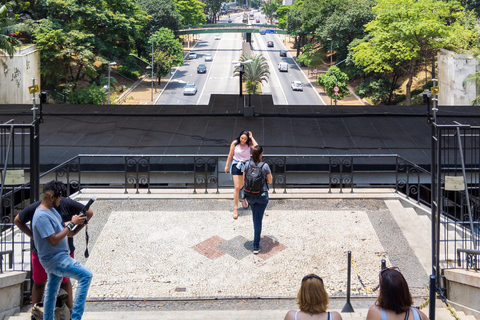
0,45,40,104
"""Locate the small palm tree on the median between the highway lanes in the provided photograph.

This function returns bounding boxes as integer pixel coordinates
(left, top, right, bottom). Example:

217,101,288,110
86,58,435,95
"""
233,53,270,94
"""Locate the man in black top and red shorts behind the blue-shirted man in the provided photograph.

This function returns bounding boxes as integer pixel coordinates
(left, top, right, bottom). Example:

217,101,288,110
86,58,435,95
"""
15,194,93,310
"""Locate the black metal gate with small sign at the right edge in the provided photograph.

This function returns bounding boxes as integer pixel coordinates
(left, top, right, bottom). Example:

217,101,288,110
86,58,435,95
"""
432,123,480,287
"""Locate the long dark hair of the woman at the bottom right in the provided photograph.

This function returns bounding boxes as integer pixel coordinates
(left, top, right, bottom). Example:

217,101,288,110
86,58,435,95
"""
377,268,413,313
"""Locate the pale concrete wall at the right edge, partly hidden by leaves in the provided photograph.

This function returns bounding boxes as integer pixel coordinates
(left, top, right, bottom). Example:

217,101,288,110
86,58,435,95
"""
438,49,480,106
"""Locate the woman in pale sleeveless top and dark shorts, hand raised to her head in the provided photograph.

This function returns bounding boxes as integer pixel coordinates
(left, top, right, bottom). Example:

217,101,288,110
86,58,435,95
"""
225,130,257,219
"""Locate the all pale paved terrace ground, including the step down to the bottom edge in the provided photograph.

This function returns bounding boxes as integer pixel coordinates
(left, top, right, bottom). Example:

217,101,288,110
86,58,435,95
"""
10,189,476,320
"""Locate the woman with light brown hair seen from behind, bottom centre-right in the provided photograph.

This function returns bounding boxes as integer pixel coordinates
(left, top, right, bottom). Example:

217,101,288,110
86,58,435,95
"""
285,274,342,320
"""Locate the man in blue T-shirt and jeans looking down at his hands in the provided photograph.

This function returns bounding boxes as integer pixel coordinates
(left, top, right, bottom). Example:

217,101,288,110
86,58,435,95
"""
32,180,92,320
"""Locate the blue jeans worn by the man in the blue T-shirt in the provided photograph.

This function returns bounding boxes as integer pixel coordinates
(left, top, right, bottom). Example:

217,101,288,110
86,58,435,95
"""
43,256,93,320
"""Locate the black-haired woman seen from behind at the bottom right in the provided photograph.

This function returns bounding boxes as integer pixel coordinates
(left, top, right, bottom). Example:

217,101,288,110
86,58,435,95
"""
367,267,428,320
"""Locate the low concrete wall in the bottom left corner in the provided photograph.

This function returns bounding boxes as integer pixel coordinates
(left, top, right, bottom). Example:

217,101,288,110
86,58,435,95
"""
0,271,27,320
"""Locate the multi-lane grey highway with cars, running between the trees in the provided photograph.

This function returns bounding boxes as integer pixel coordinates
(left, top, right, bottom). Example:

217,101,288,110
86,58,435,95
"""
156,12,325,105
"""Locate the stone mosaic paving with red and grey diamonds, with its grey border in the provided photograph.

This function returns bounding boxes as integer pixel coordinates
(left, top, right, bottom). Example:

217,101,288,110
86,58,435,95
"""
66,195,428,301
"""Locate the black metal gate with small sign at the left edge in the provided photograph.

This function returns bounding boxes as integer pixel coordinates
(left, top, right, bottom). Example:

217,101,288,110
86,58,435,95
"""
0,120,39,282
